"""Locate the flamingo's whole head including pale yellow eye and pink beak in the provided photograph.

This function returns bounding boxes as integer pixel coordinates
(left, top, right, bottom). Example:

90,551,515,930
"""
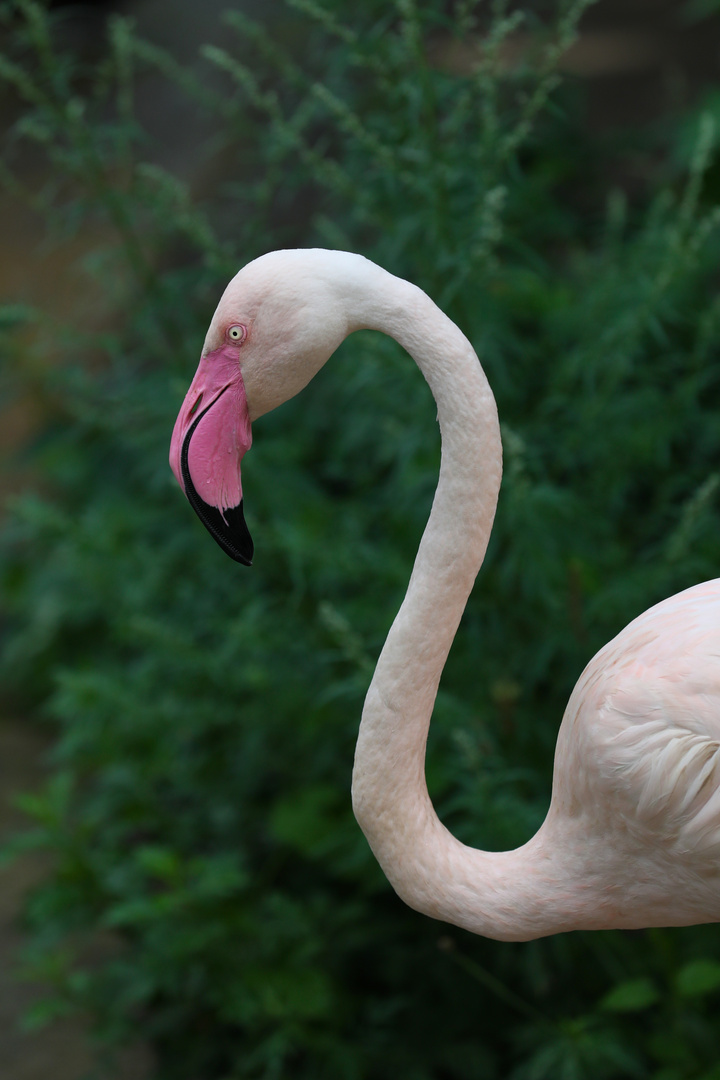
169,251,371,566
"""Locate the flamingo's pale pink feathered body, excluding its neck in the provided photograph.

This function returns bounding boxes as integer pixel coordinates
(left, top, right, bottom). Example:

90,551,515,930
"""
541,580,720,927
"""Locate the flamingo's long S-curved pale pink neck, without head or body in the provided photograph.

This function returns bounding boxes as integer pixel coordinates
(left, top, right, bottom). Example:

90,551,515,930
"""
353,267,557,940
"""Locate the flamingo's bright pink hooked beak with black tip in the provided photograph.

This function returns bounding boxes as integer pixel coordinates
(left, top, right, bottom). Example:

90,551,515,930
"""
169,345,254,566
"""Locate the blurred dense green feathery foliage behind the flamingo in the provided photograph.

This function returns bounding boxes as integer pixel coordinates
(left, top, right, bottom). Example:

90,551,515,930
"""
0,0,720,1080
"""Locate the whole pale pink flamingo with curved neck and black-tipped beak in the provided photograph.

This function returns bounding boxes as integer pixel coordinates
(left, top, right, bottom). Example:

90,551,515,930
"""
171,249,720,941
